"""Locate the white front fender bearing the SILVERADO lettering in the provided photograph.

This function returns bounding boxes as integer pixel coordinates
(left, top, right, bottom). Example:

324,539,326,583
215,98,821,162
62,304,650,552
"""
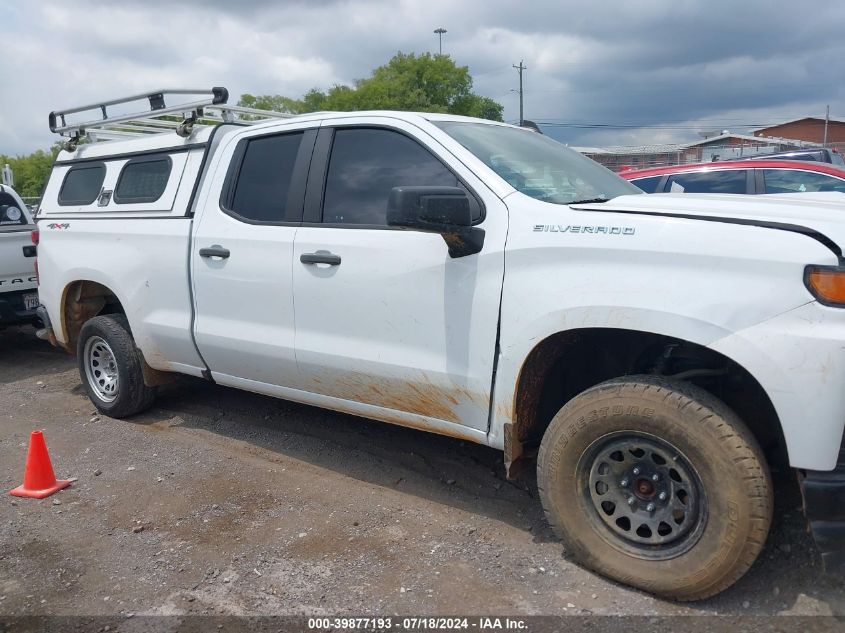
488,201,845,465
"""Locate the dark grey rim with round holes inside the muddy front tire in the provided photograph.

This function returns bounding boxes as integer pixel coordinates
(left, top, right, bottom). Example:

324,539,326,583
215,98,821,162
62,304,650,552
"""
578,431,707,559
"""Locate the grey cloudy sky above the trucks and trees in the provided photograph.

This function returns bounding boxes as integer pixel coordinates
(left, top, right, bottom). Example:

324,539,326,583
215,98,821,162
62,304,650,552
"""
0,0,845,154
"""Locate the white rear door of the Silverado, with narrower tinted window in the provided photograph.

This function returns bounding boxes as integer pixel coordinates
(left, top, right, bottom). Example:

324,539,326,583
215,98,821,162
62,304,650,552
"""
191,124,317,389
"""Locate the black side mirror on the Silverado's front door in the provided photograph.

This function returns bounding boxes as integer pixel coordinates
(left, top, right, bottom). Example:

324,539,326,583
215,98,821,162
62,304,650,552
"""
387,187,484,257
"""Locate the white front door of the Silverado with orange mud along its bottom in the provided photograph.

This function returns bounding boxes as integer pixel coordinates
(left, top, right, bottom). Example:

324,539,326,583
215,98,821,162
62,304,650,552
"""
293,117,507,431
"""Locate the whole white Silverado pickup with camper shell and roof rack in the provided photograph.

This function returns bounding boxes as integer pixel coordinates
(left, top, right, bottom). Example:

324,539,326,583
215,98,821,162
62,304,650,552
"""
38,89,845,600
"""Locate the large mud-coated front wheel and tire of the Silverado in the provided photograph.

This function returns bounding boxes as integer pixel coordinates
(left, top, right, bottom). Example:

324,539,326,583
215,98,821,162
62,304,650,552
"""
537,376,772,600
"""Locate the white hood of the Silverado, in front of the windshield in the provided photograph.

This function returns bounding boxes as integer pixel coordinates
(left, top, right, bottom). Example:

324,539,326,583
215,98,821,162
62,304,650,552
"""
571,192,845,257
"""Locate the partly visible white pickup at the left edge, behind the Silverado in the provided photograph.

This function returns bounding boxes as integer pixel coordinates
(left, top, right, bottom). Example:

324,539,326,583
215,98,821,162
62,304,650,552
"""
0,185,38,329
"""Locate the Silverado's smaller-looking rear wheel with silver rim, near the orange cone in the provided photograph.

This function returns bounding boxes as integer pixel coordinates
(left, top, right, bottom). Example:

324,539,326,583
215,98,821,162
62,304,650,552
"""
76,314,156,418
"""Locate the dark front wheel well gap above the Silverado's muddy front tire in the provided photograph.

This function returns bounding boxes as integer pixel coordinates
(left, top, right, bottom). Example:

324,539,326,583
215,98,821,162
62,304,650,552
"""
497,327,788,476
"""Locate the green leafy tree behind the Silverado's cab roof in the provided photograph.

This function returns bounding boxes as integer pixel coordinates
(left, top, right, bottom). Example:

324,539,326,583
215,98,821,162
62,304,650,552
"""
238,52,503,121
